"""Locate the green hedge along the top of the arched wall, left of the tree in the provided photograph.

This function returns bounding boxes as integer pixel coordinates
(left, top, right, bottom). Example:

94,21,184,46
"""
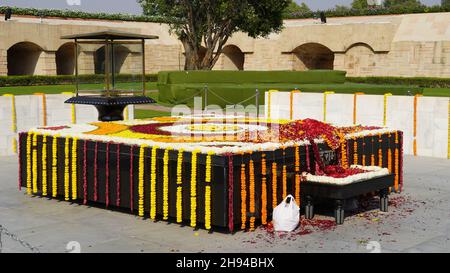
0,6,174,23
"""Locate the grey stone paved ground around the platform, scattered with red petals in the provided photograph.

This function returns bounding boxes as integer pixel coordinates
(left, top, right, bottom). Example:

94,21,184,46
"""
0,154,450,252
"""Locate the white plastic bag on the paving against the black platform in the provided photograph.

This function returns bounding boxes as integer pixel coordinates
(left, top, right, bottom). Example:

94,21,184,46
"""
272,195,300,232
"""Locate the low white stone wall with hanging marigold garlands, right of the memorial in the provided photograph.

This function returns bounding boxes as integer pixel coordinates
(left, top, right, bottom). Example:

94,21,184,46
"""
265,91,450,158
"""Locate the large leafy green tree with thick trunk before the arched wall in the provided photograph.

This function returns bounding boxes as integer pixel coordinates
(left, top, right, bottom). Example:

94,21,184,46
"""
138,0,290,70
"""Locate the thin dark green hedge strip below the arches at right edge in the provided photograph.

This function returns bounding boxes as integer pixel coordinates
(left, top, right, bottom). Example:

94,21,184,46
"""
347,77,450,88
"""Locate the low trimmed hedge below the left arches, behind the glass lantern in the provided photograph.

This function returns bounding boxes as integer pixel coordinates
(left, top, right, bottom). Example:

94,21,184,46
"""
0,74,157,87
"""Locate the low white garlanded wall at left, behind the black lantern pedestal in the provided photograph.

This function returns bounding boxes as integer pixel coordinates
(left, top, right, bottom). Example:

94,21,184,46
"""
0,93,134,156
